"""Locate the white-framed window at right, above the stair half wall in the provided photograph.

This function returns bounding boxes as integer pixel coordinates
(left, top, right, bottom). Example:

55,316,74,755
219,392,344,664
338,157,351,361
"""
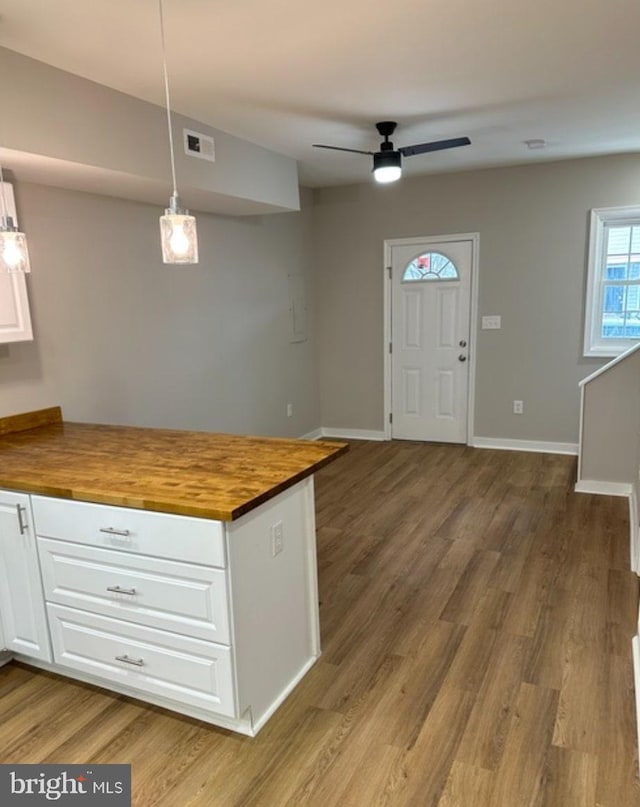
584,207,640,356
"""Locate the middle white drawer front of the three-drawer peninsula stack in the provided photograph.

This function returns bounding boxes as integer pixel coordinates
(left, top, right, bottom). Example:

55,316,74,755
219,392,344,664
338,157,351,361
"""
38,538,230,644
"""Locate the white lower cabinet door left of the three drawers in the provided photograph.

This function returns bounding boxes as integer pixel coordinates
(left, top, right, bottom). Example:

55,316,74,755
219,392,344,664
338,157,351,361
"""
0,490,51,661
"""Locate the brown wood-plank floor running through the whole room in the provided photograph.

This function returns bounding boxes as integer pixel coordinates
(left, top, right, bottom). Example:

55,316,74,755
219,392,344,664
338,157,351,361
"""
0,442,640,807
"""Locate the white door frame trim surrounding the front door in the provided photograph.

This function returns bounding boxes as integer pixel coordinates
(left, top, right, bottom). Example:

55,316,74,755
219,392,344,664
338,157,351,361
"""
382,233,480,446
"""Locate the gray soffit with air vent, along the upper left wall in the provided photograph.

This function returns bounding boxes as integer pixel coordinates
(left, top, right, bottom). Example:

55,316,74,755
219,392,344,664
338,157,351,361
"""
0,48,299,214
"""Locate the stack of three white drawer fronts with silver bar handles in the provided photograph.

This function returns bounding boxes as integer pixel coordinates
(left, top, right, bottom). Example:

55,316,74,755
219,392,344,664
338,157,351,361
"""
32,496,236,718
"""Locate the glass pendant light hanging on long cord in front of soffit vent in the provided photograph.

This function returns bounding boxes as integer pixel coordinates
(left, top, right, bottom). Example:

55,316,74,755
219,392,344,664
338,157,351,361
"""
158,0,198,264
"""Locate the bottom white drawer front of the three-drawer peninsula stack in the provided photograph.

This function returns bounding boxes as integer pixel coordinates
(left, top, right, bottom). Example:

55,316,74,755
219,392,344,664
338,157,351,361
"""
47,604,235,717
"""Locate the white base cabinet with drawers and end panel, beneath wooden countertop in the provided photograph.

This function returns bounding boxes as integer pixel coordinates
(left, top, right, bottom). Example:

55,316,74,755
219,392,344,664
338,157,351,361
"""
12,478,320,735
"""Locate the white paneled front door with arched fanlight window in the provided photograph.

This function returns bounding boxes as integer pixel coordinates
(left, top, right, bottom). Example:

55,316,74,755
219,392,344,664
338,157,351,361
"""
390,239,474,443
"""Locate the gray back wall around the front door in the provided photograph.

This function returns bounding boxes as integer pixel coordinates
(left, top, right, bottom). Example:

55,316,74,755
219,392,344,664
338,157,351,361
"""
314,155,640,443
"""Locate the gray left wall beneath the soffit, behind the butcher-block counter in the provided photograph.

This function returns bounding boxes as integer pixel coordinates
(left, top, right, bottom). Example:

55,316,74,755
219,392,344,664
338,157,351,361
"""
0,182,319,436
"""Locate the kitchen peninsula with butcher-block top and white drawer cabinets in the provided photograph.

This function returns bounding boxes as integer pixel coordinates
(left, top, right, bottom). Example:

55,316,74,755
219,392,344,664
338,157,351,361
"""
0,407,347,736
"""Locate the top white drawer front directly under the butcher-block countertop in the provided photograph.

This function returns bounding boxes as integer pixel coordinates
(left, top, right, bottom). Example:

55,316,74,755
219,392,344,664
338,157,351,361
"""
32,496,225,568
